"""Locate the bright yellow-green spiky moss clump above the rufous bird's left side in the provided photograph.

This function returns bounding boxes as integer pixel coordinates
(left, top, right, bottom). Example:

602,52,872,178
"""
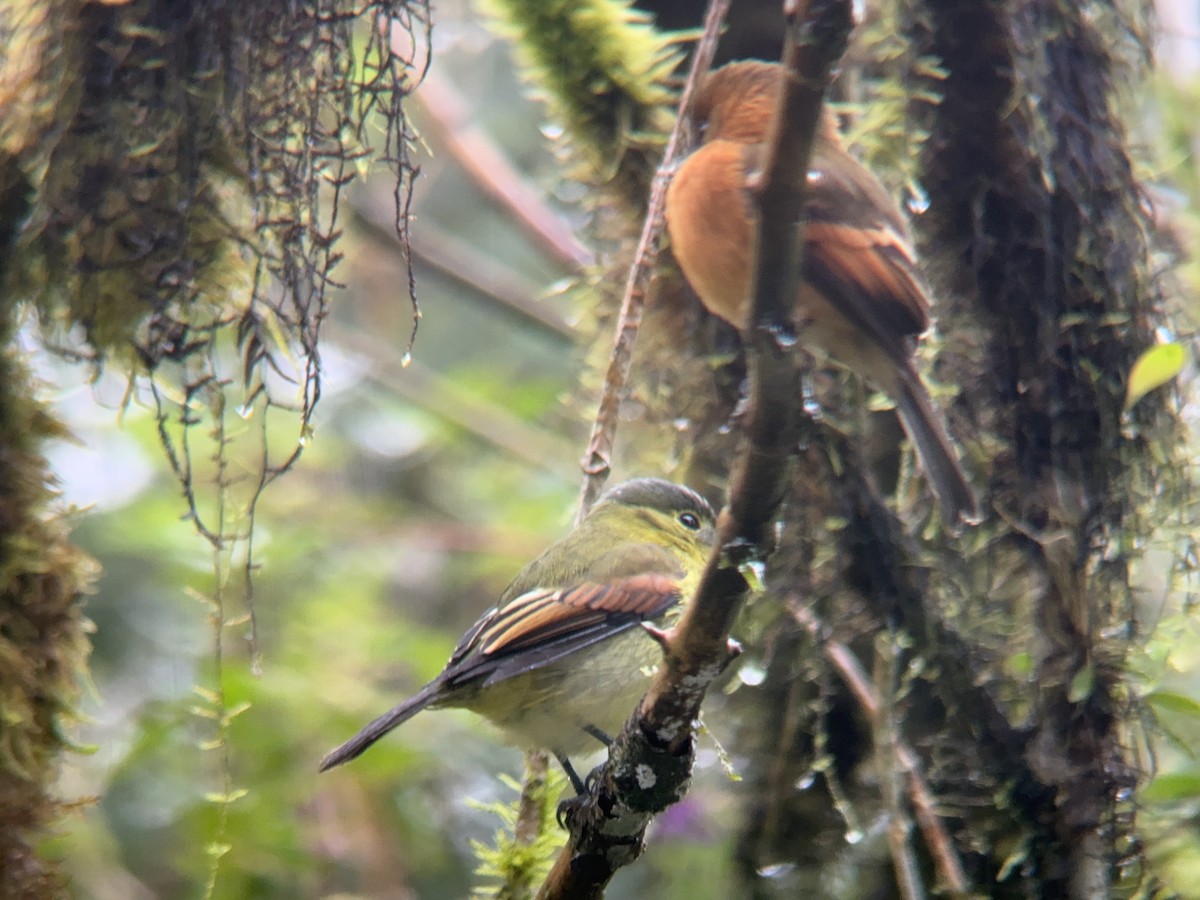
481,0,680,215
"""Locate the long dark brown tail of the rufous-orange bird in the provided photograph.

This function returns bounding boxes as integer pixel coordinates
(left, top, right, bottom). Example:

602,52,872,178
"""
893,366,982,529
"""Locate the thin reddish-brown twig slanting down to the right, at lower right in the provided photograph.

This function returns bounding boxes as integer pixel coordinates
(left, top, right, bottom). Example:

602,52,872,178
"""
788,599,968,896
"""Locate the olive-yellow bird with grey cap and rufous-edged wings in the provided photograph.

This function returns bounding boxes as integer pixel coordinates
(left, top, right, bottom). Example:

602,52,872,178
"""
320,478,715,792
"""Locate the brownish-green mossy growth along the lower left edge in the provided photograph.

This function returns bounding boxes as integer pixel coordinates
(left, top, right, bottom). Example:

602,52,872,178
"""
0,340,96,898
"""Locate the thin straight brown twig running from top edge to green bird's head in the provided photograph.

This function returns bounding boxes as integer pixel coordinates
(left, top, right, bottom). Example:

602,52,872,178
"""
575,0,730,522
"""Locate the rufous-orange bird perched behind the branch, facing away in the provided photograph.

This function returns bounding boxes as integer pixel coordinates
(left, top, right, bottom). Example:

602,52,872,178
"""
666,61,979,528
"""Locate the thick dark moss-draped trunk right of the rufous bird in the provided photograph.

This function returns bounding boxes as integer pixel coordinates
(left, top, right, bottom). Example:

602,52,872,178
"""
907,0,1161,898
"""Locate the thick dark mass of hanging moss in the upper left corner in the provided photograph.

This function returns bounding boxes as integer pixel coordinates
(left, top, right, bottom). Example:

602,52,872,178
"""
0,0,416,370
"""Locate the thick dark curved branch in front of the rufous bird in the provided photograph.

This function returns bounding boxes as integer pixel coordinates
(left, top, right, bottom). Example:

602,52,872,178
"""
539,0,852,899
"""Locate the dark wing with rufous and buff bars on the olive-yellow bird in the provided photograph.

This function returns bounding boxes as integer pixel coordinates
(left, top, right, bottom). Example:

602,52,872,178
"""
443,574,682,688
